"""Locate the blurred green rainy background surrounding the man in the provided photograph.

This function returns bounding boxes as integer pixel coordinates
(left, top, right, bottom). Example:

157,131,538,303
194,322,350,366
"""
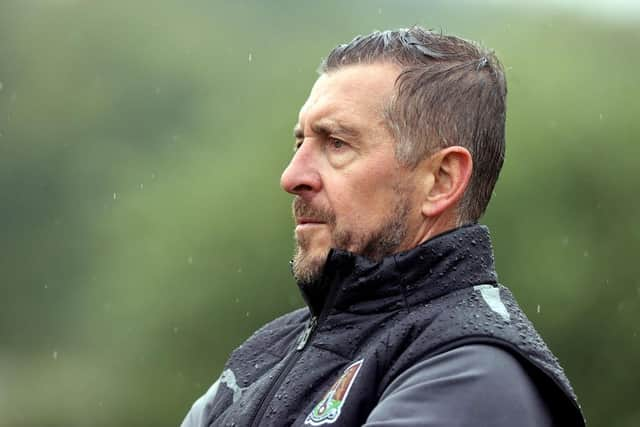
0,0,640,427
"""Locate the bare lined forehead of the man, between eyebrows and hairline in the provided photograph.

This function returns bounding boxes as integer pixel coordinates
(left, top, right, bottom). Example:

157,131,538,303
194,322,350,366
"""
298,63,399,127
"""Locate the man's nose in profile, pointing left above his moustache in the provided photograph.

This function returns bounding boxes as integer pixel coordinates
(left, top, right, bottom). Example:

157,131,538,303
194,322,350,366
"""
280,141,322,198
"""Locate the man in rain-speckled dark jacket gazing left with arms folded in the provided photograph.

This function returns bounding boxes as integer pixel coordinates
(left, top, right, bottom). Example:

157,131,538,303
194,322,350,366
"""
183,27,584,427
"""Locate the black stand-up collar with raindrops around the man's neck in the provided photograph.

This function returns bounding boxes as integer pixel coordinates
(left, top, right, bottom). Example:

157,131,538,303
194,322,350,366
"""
298,224,497,316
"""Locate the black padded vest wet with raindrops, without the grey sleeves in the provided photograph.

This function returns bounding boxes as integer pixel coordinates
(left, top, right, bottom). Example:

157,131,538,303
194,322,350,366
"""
184,225,584,426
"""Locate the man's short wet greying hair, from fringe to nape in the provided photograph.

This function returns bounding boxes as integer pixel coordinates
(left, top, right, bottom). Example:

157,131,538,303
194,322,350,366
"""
319,27,507,224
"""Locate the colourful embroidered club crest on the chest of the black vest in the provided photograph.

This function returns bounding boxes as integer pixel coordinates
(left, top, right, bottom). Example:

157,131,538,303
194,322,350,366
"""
304,359,364,426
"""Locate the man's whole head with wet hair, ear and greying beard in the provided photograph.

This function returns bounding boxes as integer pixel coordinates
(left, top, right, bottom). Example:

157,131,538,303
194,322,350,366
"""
281,28,506,281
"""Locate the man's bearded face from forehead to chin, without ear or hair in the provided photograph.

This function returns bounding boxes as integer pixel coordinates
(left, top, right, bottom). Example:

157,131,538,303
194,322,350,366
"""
281,64,420,283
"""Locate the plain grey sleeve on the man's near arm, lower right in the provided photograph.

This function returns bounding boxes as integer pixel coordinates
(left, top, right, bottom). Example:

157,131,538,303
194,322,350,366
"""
364,344,552,427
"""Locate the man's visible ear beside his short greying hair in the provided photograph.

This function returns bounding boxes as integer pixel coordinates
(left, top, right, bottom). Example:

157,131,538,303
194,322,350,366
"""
422,146,473,217
